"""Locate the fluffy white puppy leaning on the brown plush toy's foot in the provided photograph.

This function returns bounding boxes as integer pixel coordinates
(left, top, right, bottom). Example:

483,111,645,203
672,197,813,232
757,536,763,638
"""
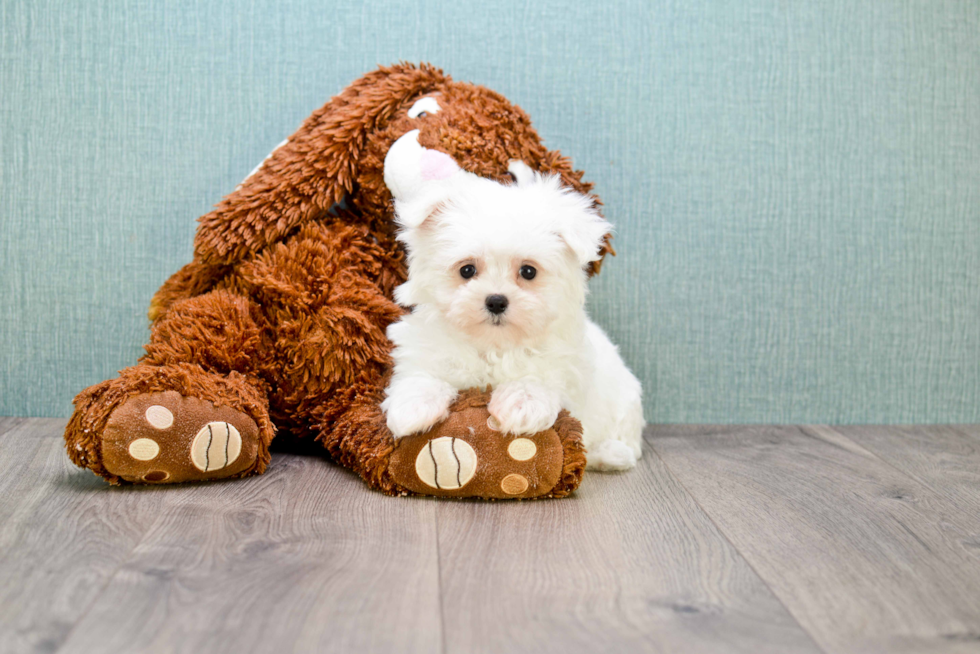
381,132,643,470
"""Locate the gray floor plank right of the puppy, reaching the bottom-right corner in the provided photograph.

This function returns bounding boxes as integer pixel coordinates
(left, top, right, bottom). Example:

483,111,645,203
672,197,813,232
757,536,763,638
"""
647,426,980,652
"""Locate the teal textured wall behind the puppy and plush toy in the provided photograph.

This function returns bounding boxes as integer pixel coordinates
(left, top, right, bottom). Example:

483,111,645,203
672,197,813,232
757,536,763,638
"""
0,0,980,422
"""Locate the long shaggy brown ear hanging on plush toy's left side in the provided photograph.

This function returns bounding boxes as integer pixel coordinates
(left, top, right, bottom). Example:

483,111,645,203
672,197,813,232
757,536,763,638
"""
194,64,449,264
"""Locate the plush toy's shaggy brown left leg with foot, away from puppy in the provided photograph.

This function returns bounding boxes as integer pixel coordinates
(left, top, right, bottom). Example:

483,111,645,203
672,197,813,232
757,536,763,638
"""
65,291,275,483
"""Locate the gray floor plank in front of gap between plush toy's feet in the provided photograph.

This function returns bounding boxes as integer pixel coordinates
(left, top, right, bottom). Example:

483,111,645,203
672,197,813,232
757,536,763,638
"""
61,455,441,652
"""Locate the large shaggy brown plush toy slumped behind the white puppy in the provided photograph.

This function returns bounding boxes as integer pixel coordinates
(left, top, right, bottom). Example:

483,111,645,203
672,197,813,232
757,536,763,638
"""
65,64,612,498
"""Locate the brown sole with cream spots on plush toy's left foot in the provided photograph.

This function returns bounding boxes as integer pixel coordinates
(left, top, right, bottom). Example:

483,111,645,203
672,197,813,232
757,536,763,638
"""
102,391,259,483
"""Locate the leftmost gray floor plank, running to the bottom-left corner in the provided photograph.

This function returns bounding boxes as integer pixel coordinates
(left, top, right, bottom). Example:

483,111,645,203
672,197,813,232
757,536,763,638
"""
0,420,179,652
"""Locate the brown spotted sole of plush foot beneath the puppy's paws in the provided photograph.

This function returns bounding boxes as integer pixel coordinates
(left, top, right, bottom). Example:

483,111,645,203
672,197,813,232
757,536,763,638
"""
388,406,564,499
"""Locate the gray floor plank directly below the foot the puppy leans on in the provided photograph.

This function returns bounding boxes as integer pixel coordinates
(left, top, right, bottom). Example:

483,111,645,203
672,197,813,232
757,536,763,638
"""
438,452,819,652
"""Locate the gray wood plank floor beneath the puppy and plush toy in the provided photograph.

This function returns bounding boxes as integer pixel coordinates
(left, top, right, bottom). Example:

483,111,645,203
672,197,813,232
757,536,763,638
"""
0,418,980,654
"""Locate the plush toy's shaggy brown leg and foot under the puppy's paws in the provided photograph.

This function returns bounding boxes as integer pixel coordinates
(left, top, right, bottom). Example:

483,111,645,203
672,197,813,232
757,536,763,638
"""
321,384,585,499
